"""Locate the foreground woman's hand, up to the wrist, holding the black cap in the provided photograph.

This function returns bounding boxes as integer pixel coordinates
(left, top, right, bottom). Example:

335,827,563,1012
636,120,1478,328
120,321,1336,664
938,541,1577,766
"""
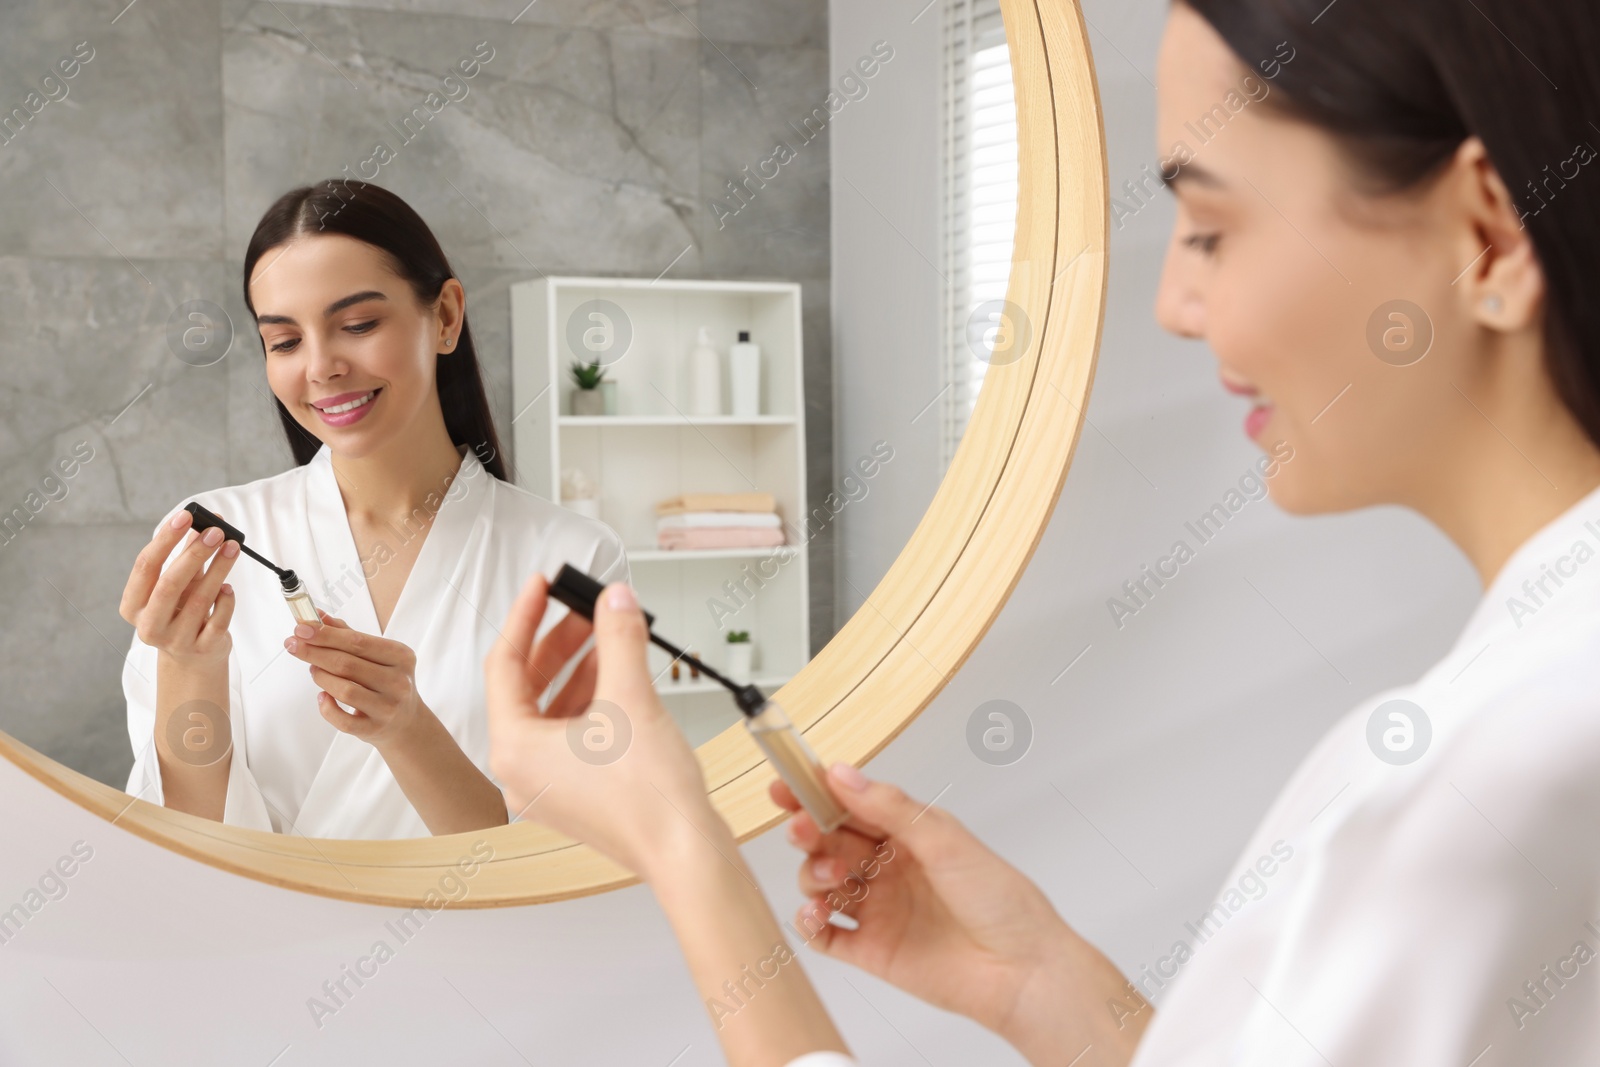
483,574,731,880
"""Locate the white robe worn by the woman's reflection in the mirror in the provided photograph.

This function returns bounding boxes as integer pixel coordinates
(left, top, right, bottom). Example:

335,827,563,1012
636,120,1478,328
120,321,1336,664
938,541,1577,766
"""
123,446,629,838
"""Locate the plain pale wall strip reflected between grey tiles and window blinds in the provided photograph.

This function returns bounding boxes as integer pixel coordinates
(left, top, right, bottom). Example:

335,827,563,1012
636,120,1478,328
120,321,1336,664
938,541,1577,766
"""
829,0,944,607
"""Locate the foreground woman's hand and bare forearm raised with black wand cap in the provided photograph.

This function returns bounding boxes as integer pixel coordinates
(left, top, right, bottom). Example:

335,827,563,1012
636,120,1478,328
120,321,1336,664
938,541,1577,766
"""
483,574,845,1067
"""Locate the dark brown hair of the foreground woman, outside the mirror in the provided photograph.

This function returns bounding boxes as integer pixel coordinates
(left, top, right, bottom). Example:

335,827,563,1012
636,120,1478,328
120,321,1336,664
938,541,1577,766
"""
1179,0,1600,445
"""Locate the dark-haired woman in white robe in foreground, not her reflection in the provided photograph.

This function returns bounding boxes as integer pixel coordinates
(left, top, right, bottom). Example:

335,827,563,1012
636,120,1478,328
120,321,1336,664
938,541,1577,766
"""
486,0,1600,1067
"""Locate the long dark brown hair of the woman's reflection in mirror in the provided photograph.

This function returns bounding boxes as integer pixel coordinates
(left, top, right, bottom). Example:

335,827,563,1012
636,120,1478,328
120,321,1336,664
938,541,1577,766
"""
245,178,509,482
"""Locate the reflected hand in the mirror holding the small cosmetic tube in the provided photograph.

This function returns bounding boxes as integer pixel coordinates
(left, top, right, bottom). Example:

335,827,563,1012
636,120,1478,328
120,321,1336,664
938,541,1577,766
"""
283,611,437,749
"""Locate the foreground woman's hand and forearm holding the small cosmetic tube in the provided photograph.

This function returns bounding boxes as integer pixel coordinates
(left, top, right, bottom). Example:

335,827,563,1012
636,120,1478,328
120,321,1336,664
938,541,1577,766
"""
771,763,1154,1067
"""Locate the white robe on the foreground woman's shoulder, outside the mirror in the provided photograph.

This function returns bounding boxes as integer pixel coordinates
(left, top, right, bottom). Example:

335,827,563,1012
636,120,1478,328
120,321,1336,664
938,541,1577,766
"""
789,490,1600,1067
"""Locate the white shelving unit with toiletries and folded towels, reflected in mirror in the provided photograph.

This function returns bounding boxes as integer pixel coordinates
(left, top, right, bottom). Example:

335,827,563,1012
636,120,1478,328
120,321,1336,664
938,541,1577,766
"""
510,277,810,744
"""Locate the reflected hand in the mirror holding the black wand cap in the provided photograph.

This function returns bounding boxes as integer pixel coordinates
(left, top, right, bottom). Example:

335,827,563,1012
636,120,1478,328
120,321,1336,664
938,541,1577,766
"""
120,510,238,667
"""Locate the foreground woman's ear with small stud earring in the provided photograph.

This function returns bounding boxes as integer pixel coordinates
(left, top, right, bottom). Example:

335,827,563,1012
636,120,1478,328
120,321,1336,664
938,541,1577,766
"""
1453,136,1544,333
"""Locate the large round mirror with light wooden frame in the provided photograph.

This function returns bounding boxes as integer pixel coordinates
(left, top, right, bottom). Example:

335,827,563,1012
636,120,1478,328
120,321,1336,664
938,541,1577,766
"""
0,0,1107,907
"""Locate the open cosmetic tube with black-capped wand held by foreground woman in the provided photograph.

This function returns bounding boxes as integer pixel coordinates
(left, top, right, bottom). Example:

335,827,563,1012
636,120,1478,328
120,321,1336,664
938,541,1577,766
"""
550,563,848,833
